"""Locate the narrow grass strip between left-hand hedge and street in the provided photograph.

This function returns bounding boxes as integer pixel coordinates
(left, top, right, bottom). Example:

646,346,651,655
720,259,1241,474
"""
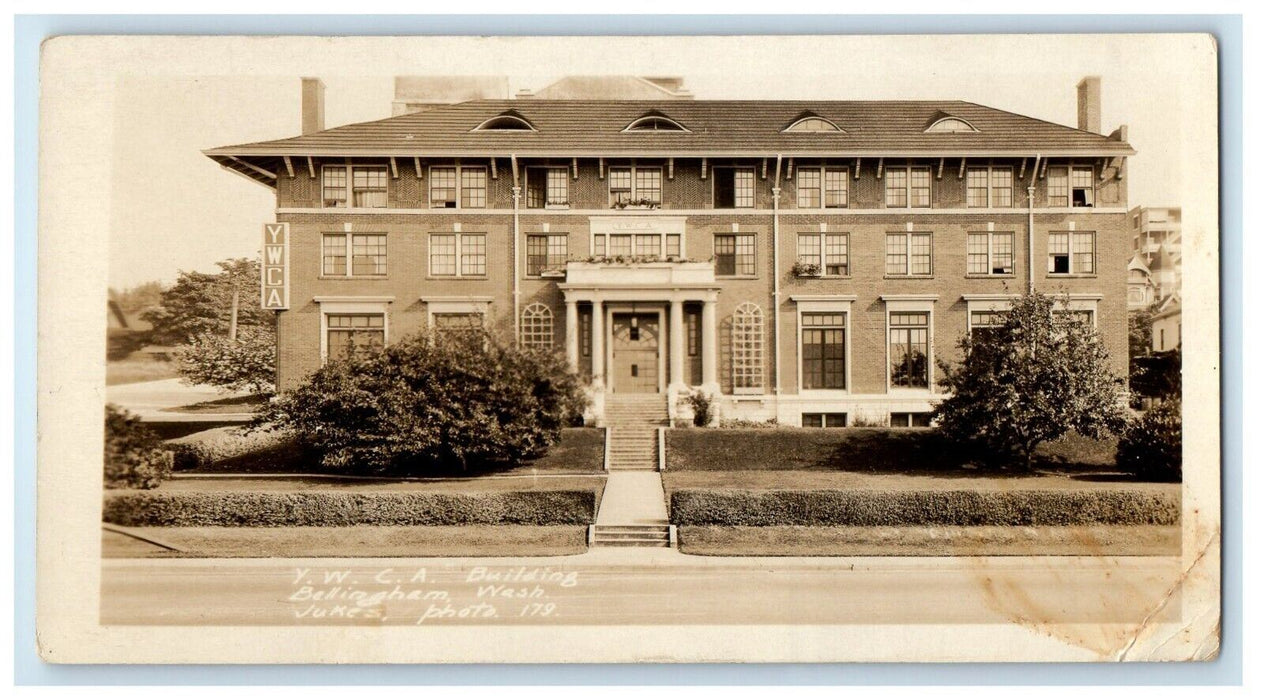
101,526,588,558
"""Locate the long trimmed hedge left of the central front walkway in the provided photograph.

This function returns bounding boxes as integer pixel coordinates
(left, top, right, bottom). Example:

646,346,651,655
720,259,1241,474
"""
104,490,597,527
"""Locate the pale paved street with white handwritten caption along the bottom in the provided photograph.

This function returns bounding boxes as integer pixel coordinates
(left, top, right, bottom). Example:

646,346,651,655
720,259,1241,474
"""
101,550,1179,625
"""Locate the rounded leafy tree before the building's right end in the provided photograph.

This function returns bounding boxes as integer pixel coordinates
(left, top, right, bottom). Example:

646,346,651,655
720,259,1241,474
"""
934,293,1125,468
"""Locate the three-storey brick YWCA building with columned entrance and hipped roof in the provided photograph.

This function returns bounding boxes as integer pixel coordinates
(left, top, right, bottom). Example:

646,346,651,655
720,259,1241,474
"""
206,78,1135,426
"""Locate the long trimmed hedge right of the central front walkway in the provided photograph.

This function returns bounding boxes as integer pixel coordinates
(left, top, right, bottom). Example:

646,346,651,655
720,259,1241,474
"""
671,489,1181,527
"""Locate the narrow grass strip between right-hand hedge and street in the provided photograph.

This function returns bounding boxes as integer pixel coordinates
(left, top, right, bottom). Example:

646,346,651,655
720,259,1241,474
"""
679,526,1181,556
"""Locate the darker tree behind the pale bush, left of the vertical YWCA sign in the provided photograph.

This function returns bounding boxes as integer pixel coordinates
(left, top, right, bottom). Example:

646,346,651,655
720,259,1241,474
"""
142,258,277,345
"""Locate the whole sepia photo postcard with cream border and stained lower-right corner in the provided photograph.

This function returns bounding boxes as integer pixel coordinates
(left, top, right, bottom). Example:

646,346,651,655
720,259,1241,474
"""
38,34,1220,663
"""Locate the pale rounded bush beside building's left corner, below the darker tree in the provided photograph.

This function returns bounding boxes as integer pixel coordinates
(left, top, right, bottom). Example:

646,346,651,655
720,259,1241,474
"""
176,326,277,394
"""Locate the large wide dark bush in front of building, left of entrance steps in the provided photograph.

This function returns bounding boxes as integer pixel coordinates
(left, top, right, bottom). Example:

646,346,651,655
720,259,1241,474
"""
254,330,585,475
